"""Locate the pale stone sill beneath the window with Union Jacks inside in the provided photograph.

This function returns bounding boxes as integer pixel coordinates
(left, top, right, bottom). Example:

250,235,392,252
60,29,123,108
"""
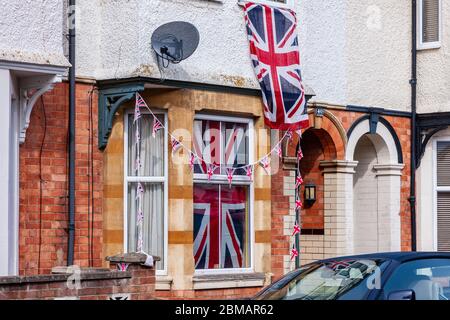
192,273,266,290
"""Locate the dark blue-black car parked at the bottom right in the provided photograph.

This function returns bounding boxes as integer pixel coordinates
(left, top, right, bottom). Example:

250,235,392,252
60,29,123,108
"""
254,252,450,300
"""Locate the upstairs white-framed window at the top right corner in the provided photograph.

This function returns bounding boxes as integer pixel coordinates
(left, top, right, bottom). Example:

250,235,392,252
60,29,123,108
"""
417,0,442,50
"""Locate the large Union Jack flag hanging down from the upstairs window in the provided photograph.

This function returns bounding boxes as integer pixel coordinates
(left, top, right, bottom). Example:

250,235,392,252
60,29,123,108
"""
244,2,309,130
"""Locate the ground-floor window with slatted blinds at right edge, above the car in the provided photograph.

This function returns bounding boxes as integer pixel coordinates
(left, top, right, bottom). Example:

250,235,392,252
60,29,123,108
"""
436,141,450,251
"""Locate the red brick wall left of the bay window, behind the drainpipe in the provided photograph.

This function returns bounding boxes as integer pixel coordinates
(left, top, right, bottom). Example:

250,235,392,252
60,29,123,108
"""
19,83,103,275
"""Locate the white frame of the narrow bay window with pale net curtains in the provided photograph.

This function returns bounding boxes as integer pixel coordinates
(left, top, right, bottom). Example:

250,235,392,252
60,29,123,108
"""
123,109,169,276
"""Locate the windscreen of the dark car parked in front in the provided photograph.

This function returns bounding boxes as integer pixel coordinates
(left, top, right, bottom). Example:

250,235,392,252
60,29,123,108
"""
255,259,384,300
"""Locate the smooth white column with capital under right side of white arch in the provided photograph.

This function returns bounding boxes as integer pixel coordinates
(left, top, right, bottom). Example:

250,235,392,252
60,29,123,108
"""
373,164,405,252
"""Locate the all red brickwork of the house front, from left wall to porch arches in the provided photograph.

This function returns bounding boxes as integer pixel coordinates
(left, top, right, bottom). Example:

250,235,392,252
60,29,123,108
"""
19,83,411,299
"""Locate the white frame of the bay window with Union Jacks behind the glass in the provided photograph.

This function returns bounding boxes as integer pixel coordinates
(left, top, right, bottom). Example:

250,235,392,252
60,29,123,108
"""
193,114,255,275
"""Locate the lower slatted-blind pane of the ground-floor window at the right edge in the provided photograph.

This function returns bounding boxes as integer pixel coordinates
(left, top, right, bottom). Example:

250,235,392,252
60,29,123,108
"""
437,192,450,252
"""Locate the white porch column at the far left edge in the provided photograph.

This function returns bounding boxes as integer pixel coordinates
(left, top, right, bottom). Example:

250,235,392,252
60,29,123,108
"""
0,69,14,276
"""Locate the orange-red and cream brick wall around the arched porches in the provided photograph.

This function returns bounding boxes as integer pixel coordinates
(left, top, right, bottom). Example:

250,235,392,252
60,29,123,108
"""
272,109,411,278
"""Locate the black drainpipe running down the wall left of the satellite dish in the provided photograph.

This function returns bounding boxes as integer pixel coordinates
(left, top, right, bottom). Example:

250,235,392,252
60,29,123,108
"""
67,0,76,266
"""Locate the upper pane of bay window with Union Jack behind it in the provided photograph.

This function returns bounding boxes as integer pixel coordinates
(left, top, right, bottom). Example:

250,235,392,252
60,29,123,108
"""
194,120,250,175
